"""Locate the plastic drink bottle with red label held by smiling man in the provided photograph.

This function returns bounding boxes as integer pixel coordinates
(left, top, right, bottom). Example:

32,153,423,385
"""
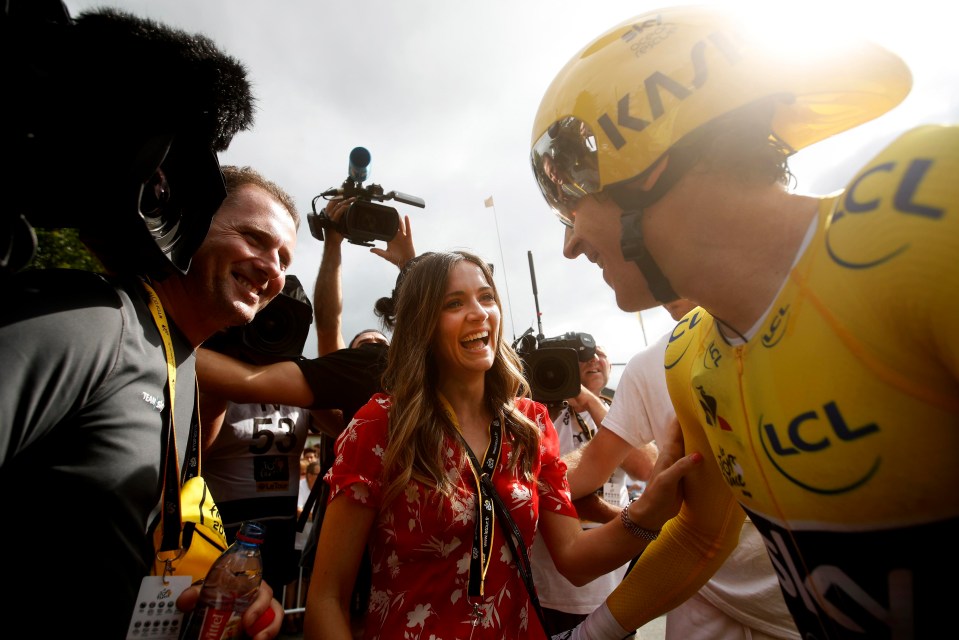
180,521,265,640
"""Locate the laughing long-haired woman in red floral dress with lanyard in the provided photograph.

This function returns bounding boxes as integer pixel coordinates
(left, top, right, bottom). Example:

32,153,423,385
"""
304,251,701,640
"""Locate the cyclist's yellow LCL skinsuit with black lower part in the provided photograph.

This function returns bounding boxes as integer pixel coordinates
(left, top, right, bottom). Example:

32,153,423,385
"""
609,126,959,639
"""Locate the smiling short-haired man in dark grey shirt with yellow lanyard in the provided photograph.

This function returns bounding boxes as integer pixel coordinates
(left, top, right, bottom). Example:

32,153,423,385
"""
0,162,298,640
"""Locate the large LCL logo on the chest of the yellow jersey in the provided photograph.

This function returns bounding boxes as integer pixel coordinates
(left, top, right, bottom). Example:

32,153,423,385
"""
759,401,881,495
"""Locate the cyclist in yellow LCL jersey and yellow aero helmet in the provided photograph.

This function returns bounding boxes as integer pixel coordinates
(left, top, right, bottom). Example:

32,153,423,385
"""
531,7,959,639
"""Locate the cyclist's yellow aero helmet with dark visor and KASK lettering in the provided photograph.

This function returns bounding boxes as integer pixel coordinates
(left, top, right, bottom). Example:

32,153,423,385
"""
530,7,912,224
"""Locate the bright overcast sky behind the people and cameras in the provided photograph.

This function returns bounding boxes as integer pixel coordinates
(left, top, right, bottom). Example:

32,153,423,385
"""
66,0,959,384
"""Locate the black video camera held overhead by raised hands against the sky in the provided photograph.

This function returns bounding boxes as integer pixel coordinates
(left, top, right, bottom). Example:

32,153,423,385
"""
306,147,426,247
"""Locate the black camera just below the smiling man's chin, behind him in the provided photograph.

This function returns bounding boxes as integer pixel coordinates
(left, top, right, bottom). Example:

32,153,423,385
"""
203,275,313,364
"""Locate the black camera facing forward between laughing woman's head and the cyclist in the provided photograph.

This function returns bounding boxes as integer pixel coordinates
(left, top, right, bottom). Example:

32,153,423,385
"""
513,329,596,405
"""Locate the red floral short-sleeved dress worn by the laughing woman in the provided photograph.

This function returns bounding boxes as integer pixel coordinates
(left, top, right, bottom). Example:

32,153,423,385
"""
324,394,576,640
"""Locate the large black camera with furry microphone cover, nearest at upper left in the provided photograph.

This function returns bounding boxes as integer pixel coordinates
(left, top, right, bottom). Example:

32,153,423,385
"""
0,0,253,277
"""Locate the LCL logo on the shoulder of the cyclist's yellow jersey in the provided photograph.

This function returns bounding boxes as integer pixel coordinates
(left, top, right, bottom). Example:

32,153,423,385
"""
826,158,945,269
